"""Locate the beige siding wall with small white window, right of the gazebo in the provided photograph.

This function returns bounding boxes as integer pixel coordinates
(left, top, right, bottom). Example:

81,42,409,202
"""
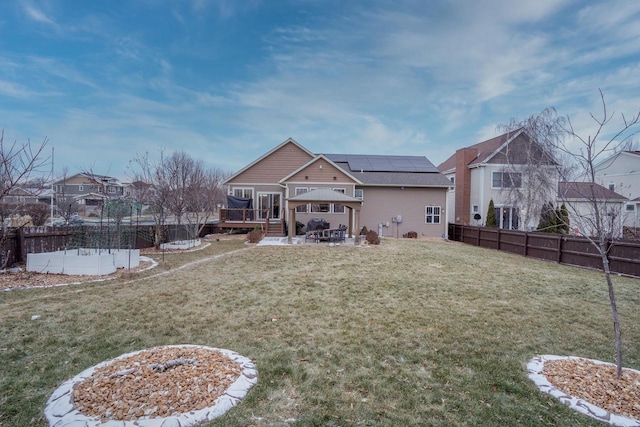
360,187,448,237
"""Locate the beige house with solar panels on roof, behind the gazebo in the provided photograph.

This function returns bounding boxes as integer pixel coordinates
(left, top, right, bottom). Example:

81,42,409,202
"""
220,138,449,242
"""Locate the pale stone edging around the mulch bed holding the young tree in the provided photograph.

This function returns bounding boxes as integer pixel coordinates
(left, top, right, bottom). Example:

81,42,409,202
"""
527,354,640,427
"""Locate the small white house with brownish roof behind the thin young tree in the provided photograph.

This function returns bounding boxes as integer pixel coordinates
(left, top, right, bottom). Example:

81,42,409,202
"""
558,182,628,238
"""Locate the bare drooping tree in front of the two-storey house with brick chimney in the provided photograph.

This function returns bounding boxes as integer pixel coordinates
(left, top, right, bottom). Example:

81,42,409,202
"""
498,108,565,232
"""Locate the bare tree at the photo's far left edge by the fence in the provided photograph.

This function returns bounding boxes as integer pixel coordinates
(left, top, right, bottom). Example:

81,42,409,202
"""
0,129,49,268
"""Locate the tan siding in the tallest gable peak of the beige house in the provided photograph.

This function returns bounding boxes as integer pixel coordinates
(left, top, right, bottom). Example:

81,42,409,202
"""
229,143,312,186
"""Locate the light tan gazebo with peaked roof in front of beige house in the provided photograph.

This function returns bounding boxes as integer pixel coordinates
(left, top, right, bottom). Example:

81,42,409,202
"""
287,188,362,244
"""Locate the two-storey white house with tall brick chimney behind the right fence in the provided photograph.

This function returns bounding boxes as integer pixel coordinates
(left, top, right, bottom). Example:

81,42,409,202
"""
438,129,558,230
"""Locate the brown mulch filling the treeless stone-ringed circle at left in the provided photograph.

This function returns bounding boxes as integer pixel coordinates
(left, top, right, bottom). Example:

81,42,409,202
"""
73,347,242,422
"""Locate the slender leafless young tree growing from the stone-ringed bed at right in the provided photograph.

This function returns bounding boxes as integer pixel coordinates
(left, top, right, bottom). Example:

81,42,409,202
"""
558,91,640,378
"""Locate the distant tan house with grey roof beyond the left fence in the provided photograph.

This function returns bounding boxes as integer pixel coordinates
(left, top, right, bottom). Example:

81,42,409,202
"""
53,173,124,214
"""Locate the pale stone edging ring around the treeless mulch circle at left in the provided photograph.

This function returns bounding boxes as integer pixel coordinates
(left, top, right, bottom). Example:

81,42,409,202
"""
44,344,258,427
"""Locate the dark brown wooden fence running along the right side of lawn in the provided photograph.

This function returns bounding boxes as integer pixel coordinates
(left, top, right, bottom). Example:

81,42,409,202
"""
449,224,640,277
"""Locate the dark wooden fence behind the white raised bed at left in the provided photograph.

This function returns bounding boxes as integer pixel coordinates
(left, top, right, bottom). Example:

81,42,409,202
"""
2,224,218,266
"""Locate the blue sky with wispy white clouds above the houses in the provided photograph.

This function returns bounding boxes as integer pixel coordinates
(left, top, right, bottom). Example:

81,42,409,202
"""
0,0,640,178
